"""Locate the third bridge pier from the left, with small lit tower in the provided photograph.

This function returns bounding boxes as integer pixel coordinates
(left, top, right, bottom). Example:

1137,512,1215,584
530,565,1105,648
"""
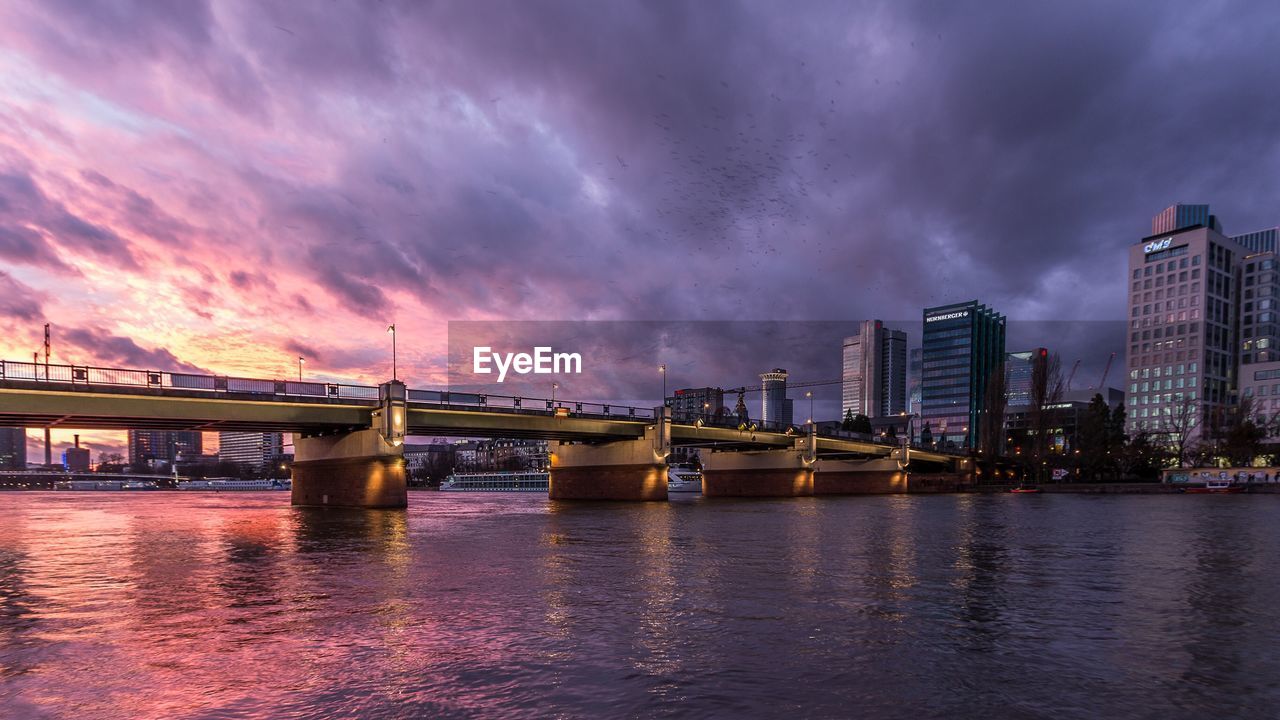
703,422,817,497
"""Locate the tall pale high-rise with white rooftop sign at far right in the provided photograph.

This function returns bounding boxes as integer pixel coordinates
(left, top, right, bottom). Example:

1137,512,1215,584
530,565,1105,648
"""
1125,199,1249,439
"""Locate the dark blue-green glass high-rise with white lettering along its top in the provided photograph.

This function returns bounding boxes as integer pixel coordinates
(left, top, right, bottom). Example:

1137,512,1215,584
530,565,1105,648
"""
920,300,1005,447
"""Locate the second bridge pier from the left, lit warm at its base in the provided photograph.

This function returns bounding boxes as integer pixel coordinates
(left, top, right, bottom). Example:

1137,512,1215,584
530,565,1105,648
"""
547,407,671,500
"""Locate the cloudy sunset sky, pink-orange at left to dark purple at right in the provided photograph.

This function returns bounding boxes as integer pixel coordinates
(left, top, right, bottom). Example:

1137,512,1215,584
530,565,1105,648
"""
0,0,1280,451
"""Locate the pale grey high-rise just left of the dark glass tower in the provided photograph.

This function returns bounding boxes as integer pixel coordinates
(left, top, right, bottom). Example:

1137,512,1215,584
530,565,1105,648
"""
840,320,906,418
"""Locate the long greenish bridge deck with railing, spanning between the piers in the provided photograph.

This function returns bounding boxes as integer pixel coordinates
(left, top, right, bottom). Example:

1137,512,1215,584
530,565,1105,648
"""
0,364,954,462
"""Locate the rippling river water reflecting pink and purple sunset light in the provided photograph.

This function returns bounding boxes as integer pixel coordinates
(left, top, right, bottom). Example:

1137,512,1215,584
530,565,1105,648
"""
0,492,1280,719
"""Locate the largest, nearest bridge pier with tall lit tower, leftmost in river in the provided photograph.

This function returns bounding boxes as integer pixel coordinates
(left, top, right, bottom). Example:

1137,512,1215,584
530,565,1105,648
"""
291,380,408,507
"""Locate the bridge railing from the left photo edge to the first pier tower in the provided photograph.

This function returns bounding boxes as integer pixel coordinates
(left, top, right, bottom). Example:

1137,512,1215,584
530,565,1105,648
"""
0,360,378,401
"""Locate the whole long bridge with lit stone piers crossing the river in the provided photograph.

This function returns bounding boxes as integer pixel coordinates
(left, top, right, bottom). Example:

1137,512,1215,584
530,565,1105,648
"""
0,361,969,507
